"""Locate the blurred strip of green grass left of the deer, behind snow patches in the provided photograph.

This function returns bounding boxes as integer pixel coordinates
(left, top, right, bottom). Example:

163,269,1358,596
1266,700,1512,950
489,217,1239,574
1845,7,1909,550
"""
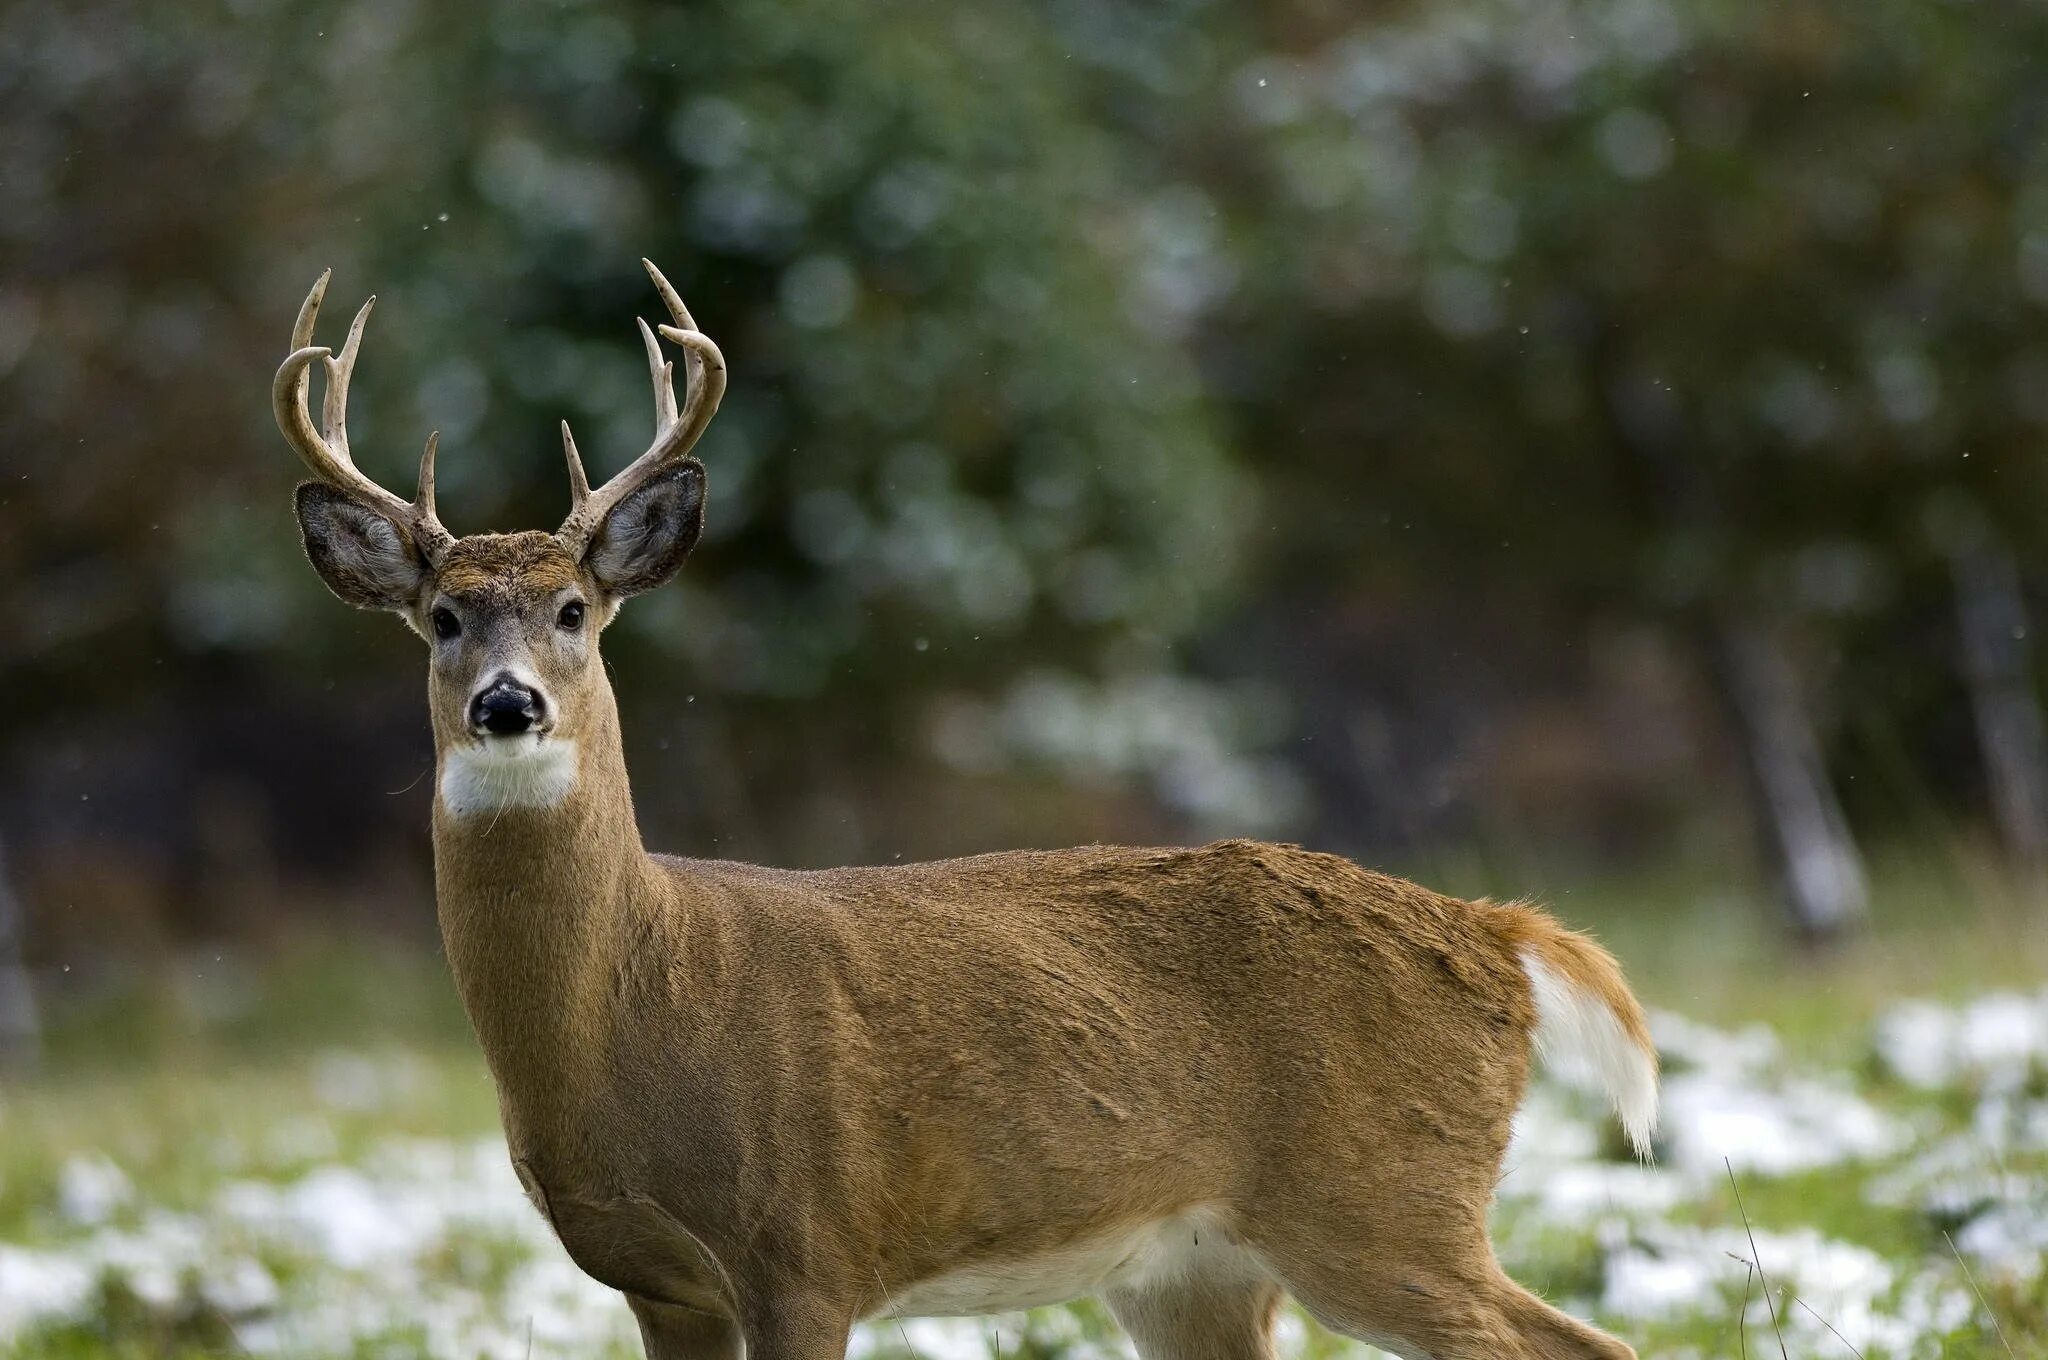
0,940,498,1241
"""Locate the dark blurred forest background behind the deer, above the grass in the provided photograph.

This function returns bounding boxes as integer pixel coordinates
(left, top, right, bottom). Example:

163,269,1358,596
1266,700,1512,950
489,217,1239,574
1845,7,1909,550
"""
0,0,2048,1065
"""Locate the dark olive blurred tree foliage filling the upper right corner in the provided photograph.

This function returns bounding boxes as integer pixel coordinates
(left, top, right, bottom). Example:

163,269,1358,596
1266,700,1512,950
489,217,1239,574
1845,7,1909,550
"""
1219,0,2048,819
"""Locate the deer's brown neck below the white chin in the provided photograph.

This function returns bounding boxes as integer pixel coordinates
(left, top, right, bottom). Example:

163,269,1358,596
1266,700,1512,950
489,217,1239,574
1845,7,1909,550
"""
434,686,659,1118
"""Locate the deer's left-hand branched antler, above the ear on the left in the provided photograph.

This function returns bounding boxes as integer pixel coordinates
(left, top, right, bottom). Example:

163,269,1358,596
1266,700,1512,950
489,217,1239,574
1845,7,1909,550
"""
270,268,455,563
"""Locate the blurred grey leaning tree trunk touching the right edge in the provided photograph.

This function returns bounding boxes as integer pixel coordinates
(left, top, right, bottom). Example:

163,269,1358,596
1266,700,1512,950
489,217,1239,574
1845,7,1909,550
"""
1948,522,2048,885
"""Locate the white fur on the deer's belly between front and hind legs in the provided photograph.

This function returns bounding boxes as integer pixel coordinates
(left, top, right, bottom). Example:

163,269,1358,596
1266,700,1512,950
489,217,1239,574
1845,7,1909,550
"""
883,1206,1264,1317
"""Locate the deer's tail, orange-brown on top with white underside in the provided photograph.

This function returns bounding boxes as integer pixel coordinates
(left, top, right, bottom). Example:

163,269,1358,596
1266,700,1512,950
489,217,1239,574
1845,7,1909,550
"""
1491,905,1657,1159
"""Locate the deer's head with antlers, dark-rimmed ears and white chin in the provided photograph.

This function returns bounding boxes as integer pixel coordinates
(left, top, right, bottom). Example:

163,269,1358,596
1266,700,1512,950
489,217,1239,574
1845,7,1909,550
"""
270,260,725,813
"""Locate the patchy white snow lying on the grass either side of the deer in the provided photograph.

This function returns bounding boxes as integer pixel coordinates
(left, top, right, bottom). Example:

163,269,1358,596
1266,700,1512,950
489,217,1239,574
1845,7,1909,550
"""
0,991,2048,1360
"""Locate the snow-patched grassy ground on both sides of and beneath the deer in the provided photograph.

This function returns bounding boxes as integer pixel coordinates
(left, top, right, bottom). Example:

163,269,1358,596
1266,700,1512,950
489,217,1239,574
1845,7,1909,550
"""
0,852,2048,1360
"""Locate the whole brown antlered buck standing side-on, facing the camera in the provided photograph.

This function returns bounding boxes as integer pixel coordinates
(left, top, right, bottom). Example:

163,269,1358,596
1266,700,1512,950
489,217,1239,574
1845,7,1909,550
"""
272,260,1657,1360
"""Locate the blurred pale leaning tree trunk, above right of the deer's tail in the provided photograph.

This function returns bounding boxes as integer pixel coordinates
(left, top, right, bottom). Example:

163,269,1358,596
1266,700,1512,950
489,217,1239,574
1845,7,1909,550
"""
1714,619,1870,944
